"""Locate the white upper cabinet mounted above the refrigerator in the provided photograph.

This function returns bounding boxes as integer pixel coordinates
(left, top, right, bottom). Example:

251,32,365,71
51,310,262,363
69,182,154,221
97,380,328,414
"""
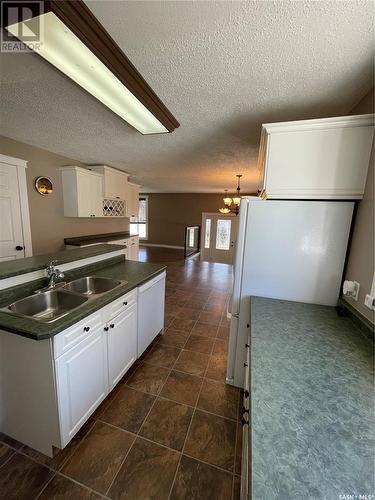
258,114,374,199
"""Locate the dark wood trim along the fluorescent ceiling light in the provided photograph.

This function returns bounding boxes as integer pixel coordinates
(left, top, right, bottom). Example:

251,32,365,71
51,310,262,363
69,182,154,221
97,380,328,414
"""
2,0,180,132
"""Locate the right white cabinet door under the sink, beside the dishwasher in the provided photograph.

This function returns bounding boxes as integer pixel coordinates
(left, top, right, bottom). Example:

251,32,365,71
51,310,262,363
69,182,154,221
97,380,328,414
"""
105,304,137,390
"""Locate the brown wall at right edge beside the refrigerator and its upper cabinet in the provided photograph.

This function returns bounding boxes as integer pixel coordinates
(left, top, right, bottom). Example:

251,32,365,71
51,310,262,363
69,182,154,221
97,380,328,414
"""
345,88,375,323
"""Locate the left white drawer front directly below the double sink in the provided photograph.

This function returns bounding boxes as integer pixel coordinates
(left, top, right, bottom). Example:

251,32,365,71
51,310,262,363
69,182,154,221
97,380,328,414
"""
53,311,102,359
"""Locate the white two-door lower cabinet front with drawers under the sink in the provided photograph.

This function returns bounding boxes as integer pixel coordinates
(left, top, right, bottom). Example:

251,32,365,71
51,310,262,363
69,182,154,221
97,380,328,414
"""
54,291,138,447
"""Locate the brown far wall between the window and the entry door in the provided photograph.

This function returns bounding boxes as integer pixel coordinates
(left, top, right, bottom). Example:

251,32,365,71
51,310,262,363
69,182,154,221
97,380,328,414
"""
147,193,242,246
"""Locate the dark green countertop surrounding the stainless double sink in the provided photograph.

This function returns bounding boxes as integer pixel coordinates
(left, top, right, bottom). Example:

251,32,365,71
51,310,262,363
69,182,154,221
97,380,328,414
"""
0,258,165,340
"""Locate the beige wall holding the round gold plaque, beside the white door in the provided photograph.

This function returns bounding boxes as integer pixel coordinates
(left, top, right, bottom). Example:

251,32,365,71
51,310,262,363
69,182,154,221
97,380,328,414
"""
0,136,129,255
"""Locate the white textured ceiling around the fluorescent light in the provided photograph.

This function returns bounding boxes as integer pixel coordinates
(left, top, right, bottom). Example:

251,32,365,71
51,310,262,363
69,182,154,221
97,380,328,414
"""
0,0,374,192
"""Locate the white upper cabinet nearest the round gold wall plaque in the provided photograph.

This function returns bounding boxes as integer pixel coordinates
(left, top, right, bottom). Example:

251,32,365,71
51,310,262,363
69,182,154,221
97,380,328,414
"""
61,167,103,217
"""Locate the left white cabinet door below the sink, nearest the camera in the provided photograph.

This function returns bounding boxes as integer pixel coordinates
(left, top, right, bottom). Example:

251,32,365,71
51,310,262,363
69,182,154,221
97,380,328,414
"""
55,327,108,447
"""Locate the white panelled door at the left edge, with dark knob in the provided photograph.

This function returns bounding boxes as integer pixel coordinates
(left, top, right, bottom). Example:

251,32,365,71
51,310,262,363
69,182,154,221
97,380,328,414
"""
0,154,32,262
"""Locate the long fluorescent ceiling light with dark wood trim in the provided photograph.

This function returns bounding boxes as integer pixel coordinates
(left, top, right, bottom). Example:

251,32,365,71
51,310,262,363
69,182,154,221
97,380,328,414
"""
2,0,179,134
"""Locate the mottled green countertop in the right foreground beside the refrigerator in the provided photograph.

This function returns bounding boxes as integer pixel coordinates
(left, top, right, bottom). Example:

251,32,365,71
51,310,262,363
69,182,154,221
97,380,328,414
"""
250,297,375,500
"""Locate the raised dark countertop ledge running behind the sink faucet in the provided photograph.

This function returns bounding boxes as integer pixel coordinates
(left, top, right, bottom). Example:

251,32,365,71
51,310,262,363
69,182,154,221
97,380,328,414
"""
0,245,125,280
